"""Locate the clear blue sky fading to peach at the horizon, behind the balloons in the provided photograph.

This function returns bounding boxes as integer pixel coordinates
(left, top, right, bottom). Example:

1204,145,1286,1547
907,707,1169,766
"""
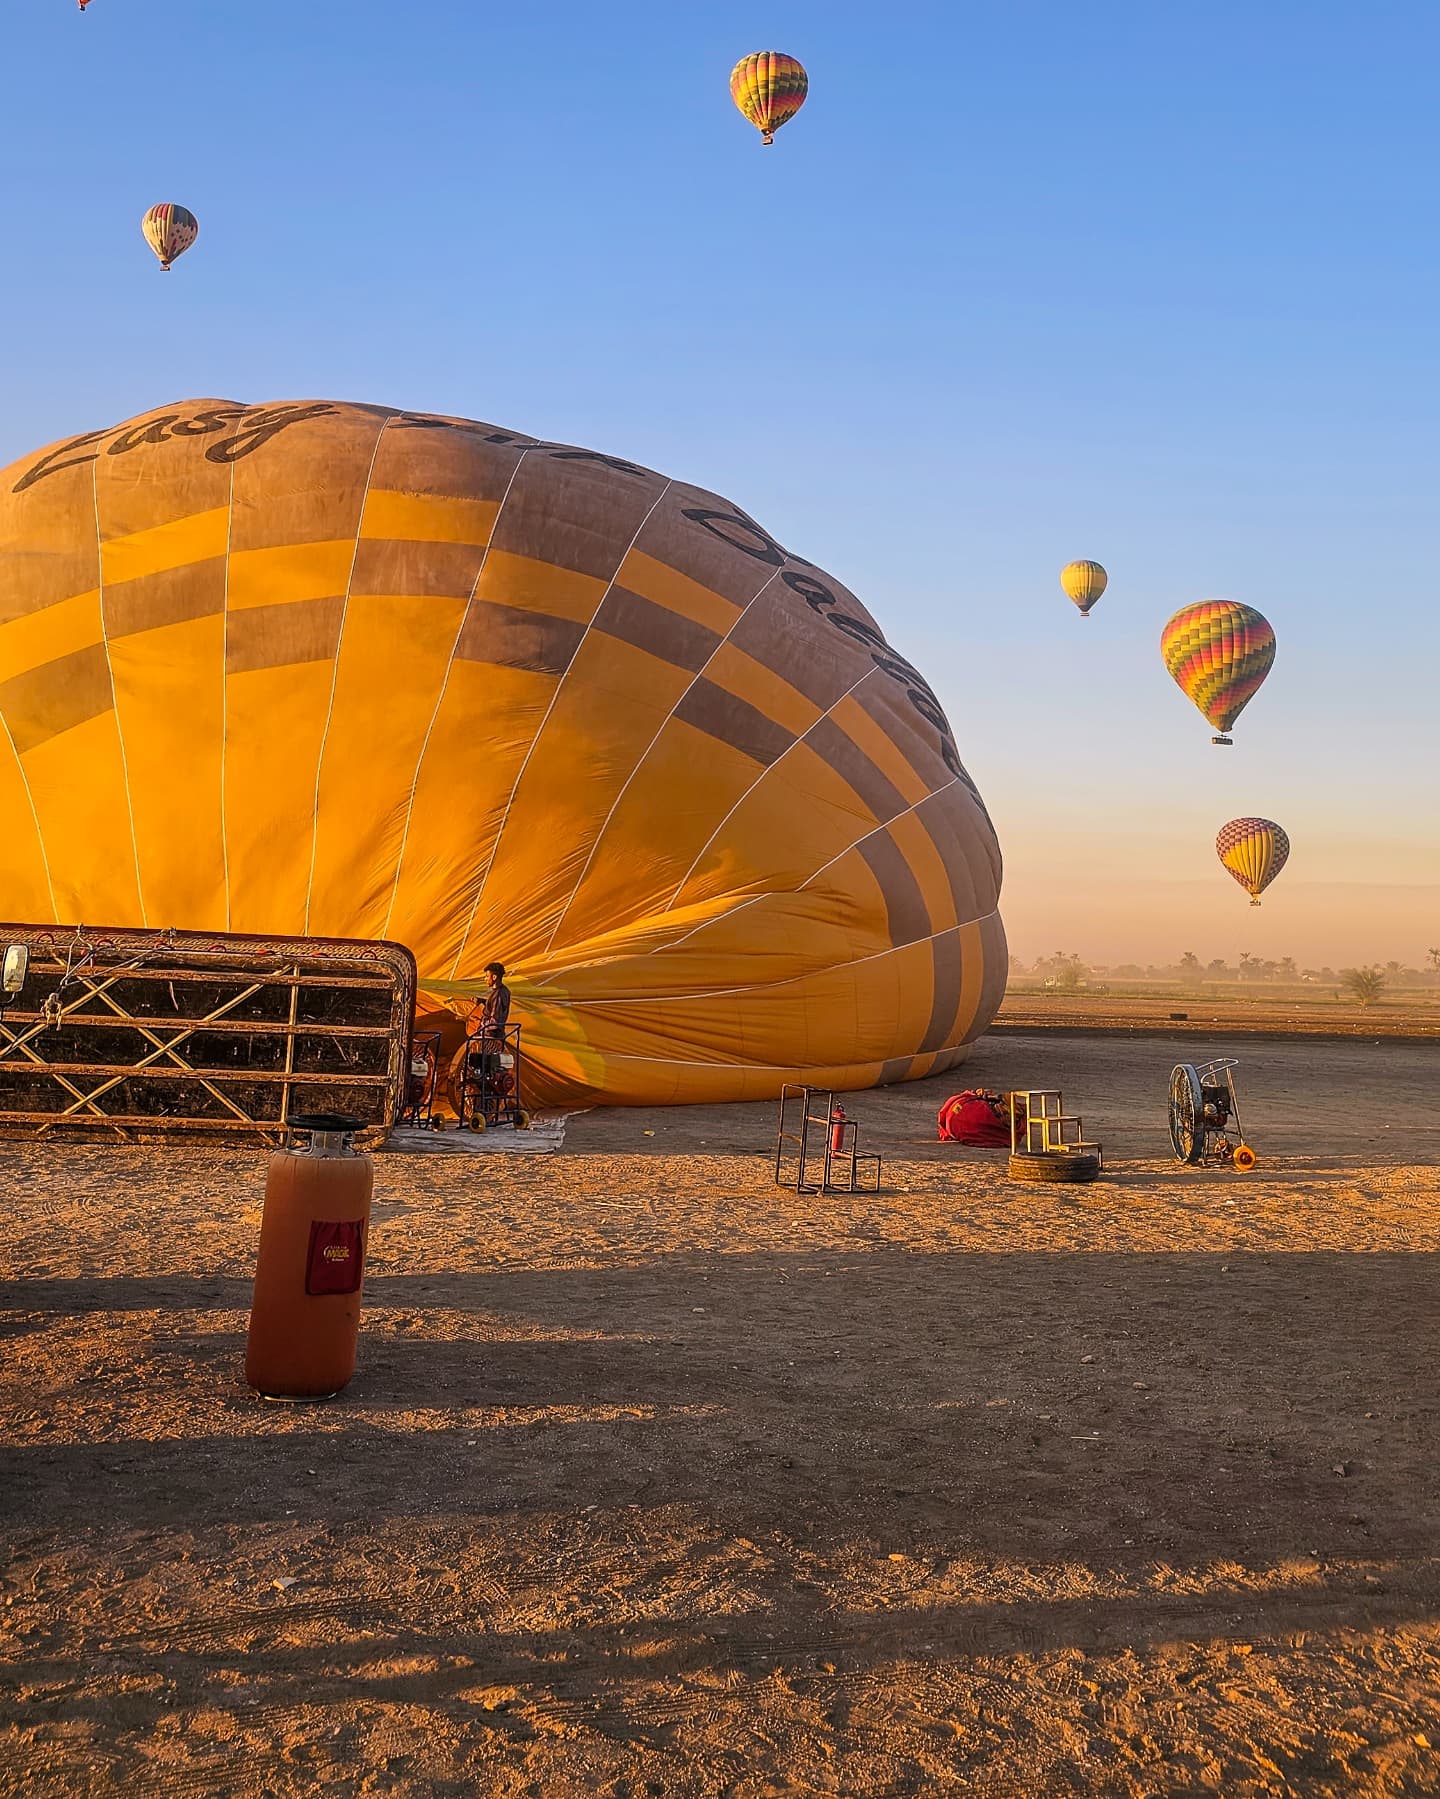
0,0,1440,966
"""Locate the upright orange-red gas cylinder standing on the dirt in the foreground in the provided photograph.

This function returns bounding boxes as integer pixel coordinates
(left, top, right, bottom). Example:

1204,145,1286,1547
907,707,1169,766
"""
245,1114,374,1400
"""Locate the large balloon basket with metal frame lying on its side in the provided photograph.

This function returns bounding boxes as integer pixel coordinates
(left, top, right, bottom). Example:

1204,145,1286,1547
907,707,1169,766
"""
0,925,416,1146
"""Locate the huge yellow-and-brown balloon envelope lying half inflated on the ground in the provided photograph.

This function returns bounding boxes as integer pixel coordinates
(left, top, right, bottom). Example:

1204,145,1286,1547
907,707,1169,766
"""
0,401,1006,1105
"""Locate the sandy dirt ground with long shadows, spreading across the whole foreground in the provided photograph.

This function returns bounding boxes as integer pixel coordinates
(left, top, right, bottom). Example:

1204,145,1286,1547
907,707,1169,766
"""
0,1034,1440,1799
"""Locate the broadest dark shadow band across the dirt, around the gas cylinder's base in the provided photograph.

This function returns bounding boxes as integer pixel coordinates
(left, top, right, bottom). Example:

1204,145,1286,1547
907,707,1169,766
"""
0,1245,1440,1583
